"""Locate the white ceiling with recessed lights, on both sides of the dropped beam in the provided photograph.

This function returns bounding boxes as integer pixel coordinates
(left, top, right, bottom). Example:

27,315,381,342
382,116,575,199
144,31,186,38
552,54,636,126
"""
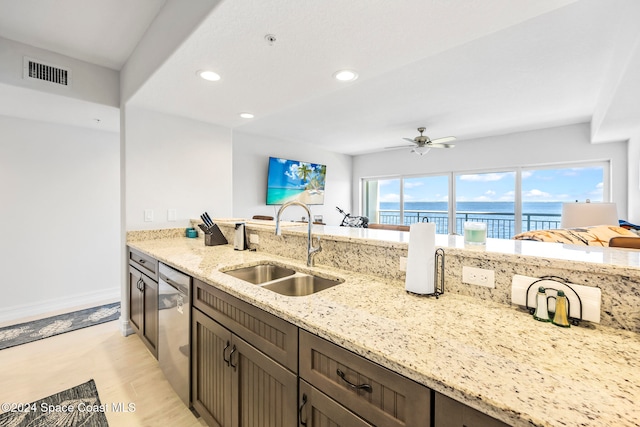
0,0,637,154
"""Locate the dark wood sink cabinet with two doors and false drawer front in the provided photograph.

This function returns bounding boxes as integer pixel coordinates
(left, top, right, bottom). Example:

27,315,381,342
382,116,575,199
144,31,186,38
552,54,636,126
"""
191,280,298,427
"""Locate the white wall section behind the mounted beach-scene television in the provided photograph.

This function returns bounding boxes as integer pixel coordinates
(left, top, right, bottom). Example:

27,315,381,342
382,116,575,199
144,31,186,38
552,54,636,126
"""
233,131,352,225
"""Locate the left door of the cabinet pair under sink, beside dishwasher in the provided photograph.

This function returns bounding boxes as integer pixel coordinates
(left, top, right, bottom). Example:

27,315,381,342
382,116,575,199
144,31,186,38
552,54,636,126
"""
191,309,233,427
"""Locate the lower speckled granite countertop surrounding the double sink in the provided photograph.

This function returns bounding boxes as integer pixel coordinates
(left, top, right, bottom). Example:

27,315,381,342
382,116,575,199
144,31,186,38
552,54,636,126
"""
129,237,640,427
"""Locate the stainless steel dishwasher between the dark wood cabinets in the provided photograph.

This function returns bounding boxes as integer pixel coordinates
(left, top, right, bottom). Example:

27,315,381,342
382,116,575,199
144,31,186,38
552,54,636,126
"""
158,263,191,406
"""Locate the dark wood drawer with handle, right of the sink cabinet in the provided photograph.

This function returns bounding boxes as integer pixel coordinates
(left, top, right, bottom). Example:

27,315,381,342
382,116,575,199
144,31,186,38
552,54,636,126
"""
300,330,431,427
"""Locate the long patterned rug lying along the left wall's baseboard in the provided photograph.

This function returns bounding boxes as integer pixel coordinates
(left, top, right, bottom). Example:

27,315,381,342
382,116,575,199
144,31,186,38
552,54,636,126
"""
0,302,120,350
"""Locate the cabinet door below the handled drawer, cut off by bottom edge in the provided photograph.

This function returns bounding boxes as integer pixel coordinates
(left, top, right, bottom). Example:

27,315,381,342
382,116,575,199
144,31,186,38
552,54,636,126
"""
298,380,373,427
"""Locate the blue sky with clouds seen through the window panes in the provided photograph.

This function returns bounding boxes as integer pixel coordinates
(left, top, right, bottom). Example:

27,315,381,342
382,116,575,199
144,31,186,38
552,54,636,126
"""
380,166,603,202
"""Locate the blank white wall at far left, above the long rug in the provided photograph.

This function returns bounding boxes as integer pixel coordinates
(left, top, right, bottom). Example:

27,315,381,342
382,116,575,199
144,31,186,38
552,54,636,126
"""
0,116,120,321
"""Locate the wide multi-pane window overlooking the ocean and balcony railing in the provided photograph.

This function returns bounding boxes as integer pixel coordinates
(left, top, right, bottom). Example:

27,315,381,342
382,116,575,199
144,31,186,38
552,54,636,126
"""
363,162,610,239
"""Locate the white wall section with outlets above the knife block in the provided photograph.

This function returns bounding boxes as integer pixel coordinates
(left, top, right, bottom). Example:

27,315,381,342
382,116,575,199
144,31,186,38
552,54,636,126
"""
124,106,232,230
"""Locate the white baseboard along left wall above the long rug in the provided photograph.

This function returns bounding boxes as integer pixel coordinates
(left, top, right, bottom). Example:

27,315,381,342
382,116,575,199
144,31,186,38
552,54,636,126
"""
0,287,121,323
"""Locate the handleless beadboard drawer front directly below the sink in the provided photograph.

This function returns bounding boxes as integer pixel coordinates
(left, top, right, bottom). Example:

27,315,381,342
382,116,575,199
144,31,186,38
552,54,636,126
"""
193,278,298,373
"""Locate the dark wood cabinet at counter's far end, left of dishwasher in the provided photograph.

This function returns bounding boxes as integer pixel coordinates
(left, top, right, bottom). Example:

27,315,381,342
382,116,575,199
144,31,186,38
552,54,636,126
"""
129,250,158,358
